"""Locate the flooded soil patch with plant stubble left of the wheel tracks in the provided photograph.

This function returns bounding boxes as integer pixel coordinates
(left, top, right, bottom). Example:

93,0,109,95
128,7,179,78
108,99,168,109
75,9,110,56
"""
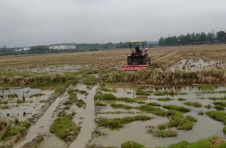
0,88,53,121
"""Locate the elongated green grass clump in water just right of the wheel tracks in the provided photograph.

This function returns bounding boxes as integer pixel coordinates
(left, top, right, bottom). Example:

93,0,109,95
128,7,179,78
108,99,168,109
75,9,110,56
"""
97,115,152,129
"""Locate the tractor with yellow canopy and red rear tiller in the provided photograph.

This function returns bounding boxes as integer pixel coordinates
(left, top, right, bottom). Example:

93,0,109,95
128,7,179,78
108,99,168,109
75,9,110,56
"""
121,41,151,71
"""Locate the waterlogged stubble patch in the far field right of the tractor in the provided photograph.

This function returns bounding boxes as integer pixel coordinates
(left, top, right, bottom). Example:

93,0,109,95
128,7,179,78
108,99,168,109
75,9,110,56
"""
168,59,226,72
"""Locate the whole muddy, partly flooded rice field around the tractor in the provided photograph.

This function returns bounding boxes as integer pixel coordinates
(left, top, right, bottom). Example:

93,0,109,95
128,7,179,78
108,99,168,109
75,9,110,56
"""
0,45,226,148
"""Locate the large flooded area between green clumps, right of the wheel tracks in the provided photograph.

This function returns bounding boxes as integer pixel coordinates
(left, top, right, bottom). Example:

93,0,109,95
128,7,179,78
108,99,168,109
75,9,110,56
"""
90,83,226,147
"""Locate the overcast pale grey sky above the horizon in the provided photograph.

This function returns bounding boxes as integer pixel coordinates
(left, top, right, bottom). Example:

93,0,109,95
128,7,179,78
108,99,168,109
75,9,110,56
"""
0,0,226,47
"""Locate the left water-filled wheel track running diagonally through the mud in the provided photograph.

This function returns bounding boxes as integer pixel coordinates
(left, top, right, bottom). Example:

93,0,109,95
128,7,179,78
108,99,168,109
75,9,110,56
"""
17,92,67,148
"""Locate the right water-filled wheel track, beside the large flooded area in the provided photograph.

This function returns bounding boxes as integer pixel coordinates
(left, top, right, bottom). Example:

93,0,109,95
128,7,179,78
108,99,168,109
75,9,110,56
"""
70,86,98,148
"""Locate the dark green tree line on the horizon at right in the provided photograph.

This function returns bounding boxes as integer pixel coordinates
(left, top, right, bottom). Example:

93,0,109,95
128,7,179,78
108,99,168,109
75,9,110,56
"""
159,31,226,46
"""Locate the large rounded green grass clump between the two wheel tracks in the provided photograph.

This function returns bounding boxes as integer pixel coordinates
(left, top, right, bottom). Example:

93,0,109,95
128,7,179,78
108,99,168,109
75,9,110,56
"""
50,115,80,141
